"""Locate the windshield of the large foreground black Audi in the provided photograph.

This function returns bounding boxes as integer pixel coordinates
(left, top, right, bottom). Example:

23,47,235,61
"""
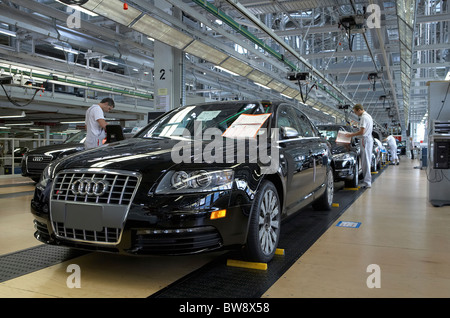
135,101,267,139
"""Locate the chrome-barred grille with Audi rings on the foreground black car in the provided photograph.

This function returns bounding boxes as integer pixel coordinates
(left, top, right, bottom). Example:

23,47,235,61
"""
50,169,140,244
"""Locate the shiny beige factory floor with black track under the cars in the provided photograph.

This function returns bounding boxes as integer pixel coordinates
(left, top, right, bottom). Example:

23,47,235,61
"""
0,157,450,298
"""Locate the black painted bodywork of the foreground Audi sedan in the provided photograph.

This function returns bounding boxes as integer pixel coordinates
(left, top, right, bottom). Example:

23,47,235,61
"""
31,103,331,254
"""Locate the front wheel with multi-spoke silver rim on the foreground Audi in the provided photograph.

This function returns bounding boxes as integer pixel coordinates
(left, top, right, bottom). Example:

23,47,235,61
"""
244,181,281,263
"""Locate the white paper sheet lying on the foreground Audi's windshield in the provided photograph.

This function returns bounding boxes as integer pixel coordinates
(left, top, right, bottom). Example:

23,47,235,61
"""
222,113,272,138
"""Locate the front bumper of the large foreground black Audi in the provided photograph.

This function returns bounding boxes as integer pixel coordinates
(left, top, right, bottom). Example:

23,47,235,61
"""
31,189,251,255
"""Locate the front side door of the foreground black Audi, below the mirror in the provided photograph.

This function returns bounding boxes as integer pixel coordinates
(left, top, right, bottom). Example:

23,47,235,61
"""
276,105,314,213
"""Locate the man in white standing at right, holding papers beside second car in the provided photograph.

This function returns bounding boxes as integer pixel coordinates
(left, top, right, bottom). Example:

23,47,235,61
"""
347,104,373,188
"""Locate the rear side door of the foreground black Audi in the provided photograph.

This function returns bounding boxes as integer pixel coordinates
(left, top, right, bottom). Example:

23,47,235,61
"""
294,109,328,192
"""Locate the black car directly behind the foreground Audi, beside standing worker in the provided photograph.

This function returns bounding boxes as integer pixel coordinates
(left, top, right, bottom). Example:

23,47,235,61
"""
317,124,362,188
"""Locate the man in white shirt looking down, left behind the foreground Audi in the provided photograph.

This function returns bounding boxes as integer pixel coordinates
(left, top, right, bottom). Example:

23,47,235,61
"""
84,97,115,149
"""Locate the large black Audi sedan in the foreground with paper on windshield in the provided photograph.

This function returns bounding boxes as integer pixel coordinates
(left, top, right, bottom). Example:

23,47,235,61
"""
31,101,334,262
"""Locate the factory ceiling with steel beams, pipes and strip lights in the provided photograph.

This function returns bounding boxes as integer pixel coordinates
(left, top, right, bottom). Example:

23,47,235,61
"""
0,0,450,136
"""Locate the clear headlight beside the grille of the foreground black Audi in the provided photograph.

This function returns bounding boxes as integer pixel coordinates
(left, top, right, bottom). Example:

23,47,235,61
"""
155,169,234,194
